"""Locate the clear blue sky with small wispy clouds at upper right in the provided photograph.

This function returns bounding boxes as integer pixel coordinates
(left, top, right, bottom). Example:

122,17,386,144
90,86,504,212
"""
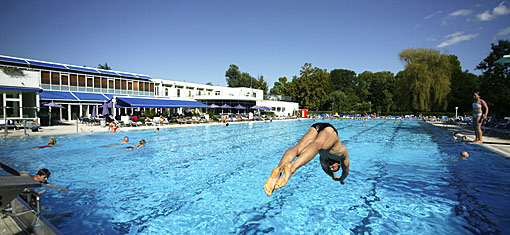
0,0,510,87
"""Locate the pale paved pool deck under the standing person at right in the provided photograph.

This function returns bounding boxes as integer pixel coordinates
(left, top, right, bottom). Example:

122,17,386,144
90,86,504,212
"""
428,122,510,159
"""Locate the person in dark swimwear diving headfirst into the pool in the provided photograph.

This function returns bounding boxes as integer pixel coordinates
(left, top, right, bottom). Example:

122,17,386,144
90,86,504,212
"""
264,123,349,196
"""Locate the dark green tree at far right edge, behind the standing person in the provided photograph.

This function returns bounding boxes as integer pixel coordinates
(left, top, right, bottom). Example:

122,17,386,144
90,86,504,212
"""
476,40,510,117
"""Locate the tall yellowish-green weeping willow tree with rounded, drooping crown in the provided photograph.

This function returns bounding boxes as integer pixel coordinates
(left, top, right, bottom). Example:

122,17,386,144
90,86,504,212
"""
399,48,451,111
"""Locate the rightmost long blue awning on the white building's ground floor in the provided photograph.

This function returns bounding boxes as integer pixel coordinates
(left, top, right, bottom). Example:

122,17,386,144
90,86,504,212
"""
117,97,209,108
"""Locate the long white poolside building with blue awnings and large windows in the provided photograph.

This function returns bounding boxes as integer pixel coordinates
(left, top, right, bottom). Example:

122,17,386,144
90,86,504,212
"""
0,55,298,125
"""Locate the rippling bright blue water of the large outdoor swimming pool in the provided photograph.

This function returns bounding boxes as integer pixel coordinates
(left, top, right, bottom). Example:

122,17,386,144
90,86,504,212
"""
0,120,510,234
